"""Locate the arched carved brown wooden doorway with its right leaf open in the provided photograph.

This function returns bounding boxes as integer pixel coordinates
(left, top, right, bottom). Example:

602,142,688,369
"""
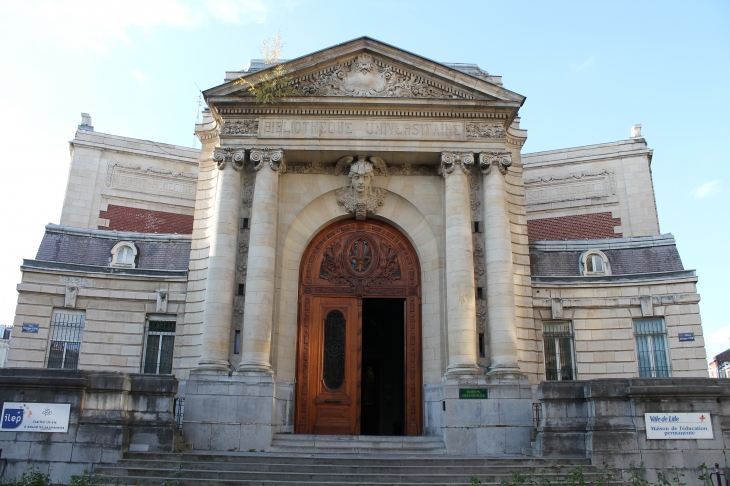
294,220,422,435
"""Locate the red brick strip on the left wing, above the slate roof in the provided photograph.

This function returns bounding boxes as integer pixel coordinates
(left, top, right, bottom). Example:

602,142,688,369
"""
99,204,193,235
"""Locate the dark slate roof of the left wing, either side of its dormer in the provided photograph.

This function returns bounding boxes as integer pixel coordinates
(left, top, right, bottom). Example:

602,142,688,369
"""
36,233,190,270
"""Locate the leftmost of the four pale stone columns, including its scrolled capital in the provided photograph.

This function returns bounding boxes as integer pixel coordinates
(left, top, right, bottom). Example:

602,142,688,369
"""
198,145,245,370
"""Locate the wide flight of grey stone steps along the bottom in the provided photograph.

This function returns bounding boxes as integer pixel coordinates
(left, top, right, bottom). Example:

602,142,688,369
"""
93,448,595,486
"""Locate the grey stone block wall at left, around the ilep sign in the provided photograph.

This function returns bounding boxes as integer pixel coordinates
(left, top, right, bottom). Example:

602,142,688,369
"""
0,368,179,482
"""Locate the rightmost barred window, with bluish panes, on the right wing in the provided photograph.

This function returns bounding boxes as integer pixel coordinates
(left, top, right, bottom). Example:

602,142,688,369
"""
634,318,670,378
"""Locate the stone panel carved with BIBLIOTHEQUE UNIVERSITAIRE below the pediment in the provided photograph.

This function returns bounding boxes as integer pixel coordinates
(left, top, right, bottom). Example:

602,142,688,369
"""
259,118,466,140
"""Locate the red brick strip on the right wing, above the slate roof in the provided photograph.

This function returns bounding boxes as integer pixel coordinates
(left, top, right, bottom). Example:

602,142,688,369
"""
524,213,622,241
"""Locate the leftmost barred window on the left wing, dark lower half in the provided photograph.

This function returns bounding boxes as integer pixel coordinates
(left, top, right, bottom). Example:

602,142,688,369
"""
46,309,86,370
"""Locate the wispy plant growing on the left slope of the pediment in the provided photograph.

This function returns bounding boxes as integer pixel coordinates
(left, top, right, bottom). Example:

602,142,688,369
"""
233,32,299,105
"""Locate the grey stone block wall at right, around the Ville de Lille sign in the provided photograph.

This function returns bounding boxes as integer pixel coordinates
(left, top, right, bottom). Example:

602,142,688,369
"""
535,378,730,480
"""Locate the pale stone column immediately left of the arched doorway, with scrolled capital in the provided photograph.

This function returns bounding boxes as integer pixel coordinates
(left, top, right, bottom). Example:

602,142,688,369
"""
238,148,286,373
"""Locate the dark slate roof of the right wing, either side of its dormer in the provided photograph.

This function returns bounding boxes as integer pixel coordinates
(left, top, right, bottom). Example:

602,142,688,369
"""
530,245,684,277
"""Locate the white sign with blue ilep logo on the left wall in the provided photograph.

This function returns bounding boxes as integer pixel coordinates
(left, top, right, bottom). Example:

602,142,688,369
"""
0,402,71,432
